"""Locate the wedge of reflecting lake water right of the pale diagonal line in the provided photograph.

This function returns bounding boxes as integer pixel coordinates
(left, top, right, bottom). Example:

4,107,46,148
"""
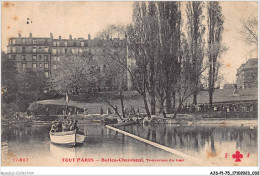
121,124,257,164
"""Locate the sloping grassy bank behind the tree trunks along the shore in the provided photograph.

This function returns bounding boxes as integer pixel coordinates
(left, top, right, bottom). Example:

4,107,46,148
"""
38,88,257,114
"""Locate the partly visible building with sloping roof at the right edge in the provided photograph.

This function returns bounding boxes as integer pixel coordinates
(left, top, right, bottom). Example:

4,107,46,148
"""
236,58,258,89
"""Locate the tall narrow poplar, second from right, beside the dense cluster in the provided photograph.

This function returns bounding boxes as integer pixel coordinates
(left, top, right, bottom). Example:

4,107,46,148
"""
186,1,205,104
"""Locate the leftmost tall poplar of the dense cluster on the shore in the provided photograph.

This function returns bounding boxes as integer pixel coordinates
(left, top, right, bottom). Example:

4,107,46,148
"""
129,2,159,115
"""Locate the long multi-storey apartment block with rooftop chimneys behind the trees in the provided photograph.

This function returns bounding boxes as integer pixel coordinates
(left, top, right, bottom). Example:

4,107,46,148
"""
7,33,130,91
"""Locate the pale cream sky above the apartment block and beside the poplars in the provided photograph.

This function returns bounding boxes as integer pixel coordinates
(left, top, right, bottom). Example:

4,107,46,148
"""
1,1,258,84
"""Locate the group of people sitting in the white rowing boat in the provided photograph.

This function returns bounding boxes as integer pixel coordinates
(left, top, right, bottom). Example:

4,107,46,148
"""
51,118,79,132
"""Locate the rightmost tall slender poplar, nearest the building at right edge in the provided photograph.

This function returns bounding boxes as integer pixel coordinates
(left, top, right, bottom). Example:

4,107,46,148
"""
207,1,224,105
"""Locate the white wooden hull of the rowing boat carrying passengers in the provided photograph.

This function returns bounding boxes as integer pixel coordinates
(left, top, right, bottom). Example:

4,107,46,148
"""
50,130,86,147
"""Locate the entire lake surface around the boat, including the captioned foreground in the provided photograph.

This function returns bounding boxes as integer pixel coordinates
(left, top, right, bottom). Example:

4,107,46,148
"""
1,123,258,166
